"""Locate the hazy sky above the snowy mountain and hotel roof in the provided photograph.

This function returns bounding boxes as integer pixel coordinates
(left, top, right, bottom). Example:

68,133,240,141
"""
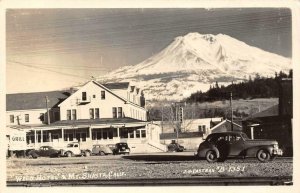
6,8,292,93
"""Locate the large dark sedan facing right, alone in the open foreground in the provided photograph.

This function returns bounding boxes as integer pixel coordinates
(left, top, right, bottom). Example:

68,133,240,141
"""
195,132,282,162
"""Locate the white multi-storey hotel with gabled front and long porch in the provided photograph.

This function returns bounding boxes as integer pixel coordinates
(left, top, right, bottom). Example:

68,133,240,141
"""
6,81,166,153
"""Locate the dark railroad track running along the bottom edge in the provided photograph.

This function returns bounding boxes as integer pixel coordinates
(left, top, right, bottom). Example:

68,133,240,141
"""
7,176,293,187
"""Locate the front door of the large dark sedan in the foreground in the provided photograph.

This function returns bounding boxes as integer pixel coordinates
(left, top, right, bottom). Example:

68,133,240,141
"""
226,134,245,156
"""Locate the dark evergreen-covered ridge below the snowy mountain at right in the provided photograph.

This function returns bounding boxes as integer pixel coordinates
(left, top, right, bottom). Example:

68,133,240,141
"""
185,70,292,103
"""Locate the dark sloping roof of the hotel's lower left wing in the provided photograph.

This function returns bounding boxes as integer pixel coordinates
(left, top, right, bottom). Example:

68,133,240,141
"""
6,91,71,111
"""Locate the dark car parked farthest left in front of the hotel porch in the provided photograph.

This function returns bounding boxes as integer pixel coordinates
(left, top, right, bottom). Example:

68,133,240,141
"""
27,146,60,159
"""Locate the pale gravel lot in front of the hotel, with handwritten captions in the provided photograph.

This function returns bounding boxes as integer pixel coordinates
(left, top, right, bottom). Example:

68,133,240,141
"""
7,152,293,182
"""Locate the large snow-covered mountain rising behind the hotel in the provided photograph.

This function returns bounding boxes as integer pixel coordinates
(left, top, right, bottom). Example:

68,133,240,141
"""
98,33,291,100
